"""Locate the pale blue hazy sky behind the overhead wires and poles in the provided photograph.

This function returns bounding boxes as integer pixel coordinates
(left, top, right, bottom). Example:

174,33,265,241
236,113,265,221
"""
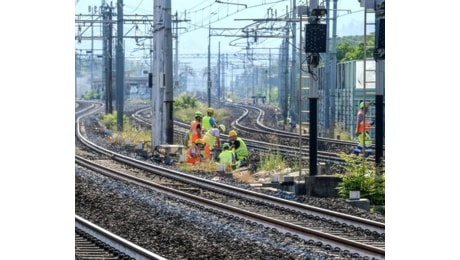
74,0,372,94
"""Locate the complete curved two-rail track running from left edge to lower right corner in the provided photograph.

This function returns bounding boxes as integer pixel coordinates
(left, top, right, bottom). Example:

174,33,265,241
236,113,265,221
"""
76,101,385,257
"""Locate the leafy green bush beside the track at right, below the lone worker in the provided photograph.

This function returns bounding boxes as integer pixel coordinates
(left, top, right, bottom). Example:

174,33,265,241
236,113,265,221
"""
336,153,385,205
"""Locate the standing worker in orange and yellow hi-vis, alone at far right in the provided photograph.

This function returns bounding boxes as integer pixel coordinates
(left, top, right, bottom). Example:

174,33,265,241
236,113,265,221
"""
353,101,374,155
